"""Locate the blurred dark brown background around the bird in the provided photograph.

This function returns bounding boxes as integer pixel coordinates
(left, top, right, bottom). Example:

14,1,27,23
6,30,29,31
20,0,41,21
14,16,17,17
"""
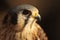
0,0,60,40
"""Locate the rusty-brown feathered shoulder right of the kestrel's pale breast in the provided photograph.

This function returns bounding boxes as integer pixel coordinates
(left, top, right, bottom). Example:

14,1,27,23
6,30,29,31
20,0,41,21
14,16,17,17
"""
35,23,48,40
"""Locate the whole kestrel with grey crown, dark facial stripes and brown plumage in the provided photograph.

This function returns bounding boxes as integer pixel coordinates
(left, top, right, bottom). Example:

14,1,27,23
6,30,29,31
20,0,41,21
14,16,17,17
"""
0,4,48,40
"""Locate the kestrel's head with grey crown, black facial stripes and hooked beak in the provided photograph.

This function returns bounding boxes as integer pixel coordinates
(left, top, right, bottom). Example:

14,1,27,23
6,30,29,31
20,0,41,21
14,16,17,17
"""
4,4,41,30
